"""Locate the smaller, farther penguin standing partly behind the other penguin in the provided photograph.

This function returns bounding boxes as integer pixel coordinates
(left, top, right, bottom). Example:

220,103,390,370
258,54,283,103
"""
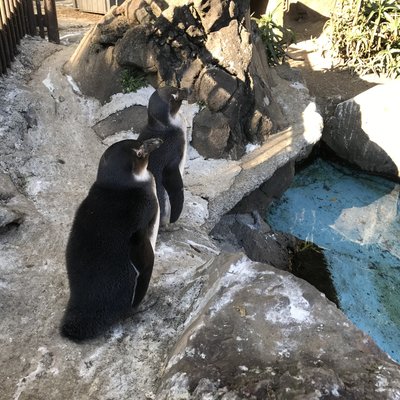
138,86,191,227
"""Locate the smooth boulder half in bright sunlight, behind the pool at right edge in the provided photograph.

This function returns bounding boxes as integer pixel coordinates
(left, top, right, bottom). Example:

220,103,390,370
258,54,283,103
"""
322,81,400,178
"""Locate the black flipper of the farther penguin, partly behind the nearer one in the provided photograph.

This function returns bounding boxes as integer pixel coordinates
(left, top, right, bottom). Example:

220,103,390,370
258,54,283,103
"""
162,166,184,223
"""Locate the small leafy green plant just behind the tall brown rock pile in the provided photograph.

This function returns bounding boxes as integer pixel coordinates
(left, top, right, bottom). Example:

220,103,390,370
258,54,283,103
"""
255,7,295,65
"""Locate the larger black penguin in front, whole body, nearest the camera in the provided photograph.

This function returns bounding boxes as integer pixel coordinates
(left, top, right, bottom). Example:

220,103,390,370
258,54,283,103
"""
60,138,162,342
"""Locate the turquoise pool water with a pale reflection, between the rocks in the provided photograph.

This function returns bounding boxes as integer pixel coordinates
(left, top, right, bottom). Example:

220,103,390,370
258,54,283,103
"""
267,160,400,362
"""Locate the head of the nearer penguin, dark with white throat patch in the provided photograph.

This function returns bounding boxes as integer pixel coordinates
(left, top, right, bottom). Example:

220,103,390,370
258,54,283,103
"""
96,138,163,189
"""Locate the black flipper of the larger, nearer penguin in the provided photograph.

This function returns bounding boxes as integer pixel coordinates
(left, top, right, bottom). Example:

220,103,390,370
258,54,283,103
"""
130,232,154,308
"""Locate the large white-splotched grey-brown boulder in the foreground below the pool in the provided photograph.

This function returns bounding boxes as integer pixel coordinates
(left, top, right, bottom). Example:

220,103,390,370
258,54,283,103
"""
157,254,400,400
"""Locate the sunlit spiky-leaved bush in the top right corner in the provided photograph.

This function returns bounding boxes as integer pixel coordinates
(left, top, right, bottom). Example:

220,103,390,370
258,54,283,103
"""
325,0,400,78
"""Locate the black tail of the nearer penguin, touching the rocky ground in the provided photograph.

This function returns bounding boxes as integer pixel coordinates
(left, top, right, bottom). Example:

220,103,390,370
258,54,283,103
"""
60,310,109,342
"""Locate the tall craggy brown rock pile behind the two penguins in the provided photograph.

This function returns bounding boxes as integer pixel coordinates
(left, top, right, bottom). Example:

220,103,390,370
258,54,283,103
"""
66,0,288,159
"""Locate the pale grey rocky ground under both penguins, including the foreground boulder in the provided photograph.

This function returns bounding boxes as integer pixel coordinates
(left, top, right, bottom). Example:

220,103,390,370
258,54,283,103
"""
0,36,400,400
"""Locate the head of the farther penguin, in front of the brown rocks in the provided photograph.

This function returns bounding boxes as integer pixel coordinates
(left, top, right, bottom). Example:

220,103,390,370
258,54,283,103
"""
147,86,191,128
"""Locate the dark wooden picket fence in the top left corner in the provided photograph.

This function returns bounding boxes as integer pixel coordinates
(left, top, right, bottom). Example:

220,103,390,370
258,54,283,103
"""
0,0,60,75
